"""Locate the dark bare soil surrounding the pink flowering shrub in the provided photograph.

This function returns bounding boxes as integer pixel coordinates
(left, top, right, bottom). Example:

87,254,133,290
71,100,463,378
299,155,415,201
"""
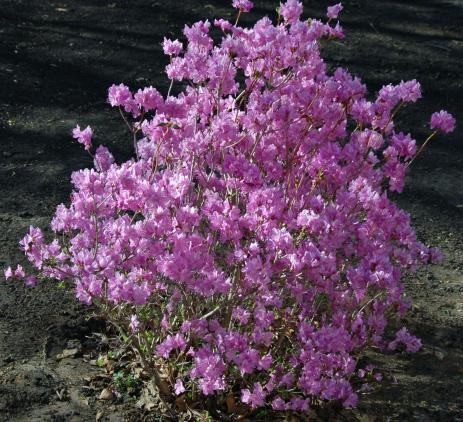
0,0,463,422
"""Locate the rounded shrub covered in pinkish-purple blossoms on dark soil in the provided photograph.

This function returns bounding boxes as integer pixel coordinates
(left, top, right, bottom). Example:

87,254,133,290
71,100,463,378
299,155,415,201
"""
5,0,455,411
